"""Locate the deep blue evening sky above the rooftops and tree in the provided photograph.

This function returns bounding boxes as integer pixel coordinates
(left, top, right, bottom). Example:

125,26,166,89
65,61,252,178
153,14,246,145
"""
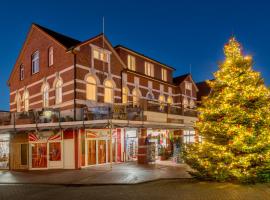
0,0,270,110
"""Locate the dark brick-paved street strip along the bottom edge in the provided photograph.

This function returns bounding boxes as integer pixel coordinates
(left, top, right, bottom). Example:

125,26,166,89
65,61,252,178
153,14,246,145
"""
0,179,270,200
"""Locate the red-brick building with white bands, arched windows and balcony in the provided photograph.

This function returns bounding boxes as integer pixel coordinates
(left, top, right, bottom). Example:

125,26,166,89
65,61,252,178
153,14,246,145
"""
0,24,198,170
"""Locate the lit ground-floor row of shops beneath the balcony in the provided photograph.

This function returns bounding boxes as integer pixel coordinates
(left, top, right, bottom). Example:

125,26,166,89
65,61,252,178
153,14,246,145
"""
4,127,196,170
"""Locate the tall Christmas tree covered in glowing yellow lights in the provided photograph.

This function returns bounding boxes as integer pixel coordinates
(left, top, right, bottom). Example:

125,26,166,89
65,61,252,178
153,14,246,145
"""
185,38,270,182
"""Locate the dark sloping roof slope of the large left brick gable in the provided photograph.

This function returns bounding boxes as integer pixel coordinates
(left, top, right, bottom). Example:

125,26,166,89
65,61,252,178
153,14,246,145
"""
33,24,81,49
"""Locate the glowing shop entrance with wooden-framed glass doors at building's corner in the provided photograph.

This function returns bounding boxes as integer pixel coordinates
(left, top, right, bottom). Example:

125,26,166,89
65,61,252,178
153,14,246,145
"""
80,129,123,167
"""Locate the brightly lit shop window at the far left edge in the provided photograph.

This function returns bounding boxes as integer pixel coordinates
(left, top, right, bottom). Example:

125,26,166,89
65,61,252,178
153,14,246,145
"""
0,133,10,169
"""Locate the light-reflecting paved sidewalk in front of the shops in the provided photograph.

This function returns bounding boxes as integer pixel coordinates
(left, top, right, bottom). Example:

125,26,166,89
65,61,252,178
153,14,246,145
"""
0,162,191,185
